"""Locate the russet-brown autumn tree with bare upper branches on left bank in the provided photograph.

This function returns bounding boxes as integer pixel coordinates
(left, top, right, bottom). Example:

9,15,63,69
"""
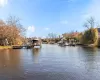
0,16,24,45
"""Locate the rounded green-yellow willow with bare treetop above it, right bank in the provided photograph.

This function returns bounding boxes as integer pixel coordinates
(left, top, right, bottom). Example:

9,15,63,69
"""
82,17,98,45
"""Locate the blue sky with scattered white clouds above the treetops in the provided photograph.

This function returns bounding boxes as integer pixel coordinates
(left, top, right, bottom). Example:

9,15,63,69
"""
0,0,100,37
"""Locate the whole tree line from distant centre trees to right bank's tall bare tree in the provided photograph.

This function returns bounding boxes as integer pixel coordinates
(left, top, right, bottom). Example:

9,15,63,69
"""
44,17,100,46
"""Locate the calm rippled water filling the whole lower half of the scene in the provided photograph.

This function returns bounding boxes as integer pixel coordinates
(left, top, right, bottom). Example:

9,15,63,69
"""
0,45,100,80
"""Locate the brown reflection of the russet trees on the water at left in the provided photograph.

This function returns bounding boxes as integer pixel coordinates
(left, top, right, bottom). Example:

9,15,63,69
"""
0,49,23,80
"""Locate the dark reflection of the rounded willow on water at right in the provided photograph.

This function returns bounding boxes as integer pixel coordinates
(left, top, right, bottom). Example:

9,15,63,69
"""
80,47,98,73
